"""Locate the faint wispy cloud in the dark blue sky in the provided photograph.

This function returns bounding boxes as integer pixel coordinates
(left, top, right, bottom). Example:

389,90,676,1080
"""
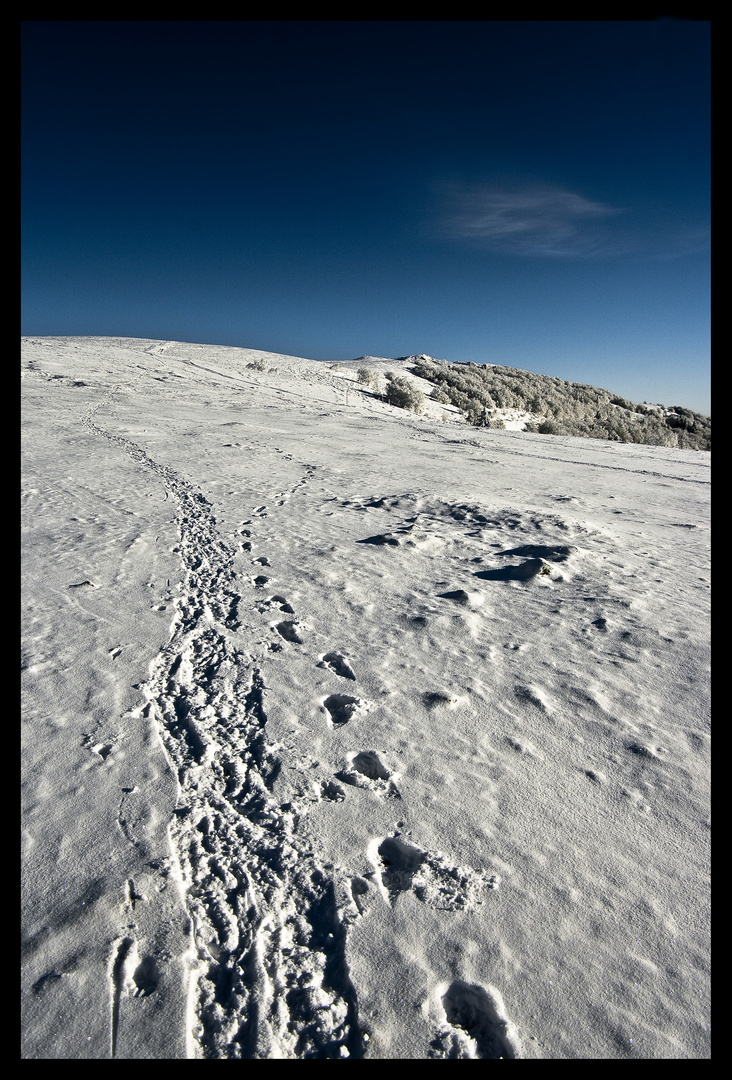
439,186,626,256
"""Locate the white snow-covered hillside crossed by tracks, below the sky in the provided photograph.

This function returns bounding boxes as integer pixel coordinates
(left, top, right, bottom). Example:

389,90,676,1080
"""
22,338,710,1058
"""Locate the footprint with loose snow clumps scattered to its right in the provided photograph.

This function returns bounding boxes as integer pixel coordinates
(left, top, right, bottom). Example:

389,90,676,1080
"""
369,831,500,912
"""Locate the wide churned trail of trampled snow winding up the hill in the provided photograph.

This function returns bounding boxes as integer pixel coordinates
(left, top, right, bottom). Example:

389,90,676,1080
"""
85,403,364,1057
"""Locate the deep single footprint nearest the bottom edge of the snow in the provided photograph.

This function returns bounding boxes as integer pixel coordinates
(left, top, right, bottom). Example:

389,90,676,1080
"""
431,978,520,1061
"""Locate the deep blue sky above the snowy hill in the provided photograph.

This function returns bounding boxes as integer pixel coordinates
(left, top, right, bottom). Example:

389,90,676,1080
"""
22,19,710,414
